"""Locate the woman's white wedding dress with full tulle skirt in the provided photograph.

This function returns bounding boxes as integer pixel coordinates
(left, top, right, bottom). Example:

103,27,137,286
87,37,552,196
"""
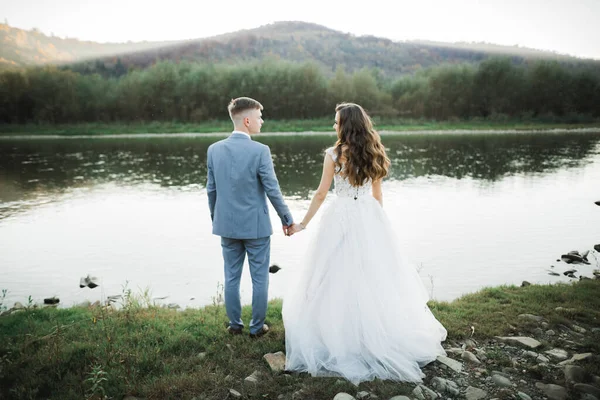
283,148,446,384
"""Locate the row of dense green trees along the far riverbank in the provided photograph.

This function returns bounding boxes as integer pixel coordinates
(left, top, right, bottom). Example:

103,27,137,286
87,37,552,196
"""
0,58,600,123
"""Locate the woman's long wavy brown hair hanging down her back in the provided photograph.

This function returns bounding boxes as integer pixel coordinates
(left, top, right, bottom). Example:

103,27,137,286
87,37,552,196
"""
334,103,390,186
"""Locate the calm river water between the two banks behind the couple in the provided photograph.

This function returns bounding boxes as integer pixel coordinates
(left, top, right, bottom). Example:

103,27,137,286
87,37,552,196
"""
0,132,600,307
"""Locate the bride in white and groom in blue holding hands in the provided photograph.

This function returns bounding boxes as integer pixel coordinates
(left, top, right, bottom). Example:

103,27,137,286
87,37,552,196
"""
206,97,446,384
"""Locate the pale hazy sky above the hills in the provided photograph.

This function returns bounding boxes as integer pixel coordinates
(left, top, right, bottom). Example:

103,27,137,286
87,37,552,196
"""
0,0,600,59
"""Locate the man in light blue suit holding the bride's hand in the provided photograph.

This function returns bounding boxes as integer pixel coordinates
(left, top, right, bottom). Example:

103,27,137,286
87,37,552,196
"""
206,97,294,337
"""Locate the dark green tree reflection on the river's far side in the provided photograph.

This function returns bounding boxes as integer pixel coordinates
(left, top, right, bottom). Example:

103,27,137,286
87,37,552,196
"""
0,132,600,219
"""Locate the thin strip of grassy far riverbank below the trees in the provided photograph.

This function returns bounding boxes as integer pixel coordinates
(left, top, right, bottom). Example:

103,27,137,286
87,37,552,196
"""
0,118,600,136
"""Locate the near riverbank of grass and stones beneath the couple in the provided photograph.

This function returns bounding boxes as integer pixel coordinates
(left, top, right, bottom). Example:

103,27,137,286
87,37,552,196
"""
0,279,600,400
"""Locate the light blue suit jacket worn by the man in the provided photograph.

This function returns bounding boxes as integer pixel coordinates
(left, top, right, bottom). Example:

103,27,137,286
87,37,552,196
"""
206,132,294,239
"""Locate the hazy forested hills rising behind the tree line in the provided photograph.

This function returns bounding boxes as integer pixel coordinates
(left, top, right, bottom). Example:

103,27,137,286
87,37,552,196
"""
0,21,600,76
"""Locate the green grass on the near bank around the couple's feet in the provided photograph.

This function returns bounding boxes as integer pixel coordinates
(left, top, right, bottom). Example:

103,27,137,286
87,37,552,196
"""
0,280,600,400
